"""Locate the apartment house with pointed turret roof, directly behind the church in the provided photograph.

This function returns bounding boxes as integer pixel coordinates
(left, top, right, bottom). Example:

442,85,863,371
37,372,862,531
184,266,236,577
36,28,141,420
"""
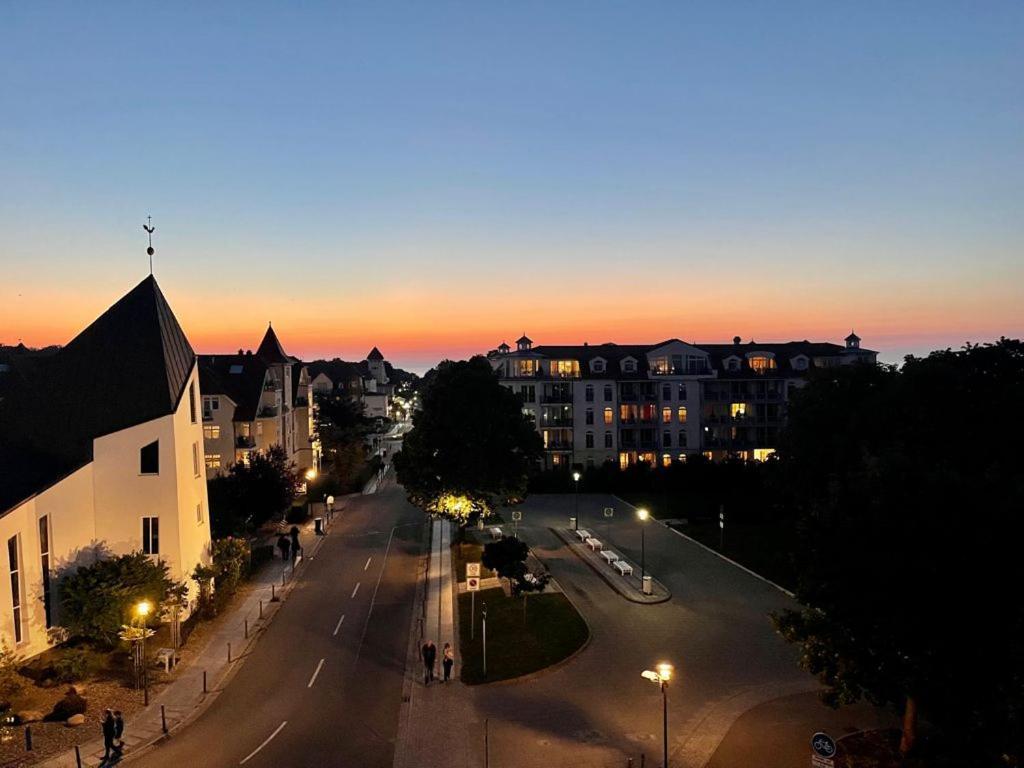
199,327,319,474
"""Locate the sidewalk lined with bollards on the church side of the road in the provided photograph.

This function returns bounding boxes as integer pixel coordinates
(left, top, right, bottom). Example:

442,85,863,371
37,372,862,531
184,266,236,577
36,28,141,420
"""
38,512,327,768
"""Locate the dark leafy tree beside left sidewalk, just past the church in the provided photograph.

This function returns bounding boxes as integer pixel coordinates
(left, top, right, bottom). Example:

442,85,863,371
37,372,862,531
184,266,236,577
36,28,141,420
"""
207,445,299,538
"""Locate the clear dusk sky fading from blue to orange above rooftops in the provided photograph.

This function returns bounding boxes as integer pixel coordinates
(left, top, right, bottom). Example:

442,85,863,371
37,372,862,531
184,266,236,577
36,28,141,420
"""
0,0,1024,371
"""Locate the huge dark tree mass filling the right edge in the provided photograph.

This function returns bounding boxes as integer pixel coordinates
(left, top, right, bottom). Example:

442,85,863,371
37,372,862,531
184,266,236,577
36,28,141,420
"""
776,339,1024,765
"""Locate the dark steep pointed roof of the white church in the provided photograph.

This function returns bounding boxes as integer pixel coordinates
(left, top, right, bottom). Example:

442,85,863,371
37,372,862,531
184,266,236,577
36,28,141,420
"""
0,275,196,513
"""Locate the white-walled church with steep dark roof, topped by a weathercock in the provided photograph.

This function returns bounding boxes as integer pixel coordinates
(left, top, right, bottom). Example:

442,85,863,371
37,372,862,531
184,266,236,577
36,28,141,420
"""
0,275,210,656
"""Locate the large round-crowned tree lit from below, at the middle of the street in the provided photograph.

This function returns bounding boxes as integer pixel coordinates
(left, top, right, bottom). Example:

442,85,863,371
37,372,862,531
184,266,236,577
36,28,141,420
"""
394,356,542,522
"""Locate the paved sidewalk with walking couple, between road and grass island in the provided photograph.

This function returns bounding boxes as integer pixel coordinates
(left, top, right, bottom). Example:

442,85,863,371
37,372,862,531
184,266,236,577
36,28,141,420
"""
394,520,482,768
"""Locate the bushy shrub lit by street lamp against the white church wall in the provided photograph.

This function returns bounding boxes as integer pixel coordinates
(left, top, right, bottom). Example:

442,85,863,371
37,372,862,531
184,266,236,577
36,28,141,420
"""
59,552,186,647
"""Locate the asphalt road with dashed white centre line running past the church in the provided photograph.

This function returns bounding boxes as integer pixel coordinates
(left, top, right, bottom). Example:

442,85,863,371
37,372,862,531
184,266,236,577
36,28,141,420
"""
138,483,423,768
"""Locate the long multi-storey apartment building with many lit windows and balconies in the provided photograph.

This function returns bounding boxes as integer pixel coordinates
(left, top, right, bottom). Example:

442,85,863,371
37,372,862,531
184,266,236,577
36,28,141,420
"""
487,334,877,469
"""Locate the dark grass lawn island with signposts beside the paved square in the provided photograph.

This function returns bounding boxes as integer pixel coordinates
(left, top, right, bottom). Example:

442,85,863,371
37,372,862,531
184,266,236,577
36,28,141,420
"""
459,589,590,685
